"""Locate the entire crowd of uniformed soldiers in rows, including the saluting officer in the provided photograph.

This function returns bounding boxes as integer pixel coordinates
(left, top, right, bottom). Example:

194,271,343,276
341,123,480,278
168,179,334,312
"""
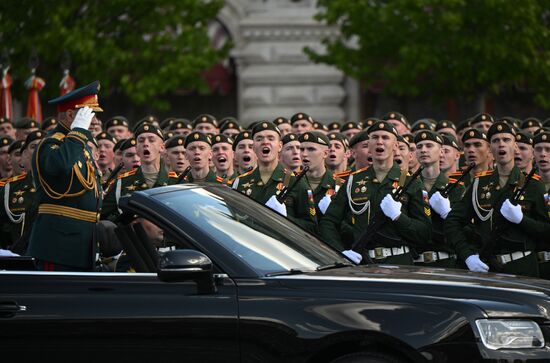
0,80,550,278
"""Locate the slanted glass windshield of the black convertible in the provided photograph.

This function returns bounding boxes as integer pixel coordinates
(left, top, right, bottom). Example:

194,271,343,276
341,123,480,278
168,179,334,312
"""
155,187,349,275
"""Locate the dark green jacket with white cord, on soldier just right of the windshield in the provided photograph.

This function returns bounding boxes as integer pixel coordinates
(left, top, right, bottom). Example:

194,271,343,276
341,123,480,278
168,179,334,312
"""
320,163,431,250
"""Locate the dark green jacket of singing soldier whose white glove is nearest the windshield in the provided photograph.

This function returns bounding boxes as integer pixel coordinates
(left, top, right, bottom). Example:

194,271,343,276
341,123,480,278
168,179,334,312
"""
233,163,317,233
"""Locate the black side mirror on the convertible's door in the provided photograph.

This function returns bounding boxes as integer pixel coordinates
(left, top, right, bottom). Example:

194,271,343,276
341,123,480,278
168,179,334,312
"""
157,250,216,294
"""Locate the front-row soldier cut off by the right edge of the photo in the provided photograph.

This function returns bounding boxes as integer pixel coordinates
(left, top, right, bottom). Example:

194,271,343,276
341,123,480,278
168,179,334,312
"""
531,131,550,279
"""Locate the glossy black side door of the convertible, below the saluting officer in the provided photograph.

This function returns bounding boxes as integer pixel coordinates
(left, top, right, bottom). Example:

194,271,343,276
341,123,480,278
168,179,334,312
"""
0,271,239,361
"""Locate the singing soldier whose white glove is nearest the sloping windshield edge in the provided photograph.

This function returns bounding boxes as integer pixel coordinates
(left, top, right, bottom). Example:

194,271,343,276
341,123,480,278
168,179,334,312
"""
232,121,317,233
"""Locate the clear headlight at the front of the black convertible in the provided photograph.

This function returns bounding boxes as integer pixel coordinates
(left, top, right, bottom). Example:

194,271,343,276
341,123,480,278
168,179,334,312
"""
476,319,544,350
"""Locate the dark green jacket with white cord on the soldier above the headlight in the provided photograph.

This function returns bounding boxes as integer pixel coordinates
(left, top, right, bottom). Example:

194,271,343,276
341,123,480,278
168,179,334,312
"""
445,167,548,260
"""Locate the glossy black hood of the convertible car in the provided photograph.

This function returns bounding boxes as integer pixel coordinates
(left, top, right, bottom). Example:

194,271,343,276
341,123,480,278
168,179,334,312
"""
275,265,550,319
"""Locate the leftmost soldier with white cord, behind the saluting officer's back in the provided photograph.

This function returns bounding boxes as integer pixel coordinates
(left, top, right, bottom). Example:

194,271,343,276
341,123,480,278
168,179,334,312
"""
0,130,45,254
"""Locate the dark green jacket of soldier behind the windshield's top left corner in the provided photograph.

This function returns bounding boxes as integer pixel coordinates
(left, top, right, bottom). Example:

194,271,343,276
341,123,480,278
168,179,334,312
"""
101,160,178,220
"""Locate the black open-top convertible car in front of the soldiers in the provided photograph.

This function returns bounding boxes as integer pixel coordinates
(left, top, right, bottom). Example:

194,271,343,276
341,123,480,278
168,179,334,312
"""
0,185,550,363
